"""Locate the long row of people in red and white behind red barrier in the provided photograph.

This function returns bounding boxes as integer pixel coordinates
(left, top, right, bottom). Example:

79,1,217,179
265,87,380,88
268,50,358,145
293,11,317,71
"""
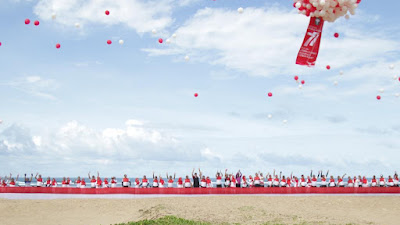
0,169,399,188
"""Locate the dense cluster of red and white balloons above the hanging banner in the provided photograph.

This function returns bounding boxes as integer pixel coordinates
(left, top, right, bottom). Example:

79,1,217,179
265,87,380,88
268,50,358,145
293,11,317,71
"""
293,0,361,22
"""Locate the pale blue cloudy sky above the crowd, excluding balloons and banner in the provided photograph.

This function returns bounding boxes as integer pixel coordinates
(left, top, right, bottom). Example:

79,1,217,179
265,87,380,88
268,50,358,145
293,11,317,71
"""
0,0,400,177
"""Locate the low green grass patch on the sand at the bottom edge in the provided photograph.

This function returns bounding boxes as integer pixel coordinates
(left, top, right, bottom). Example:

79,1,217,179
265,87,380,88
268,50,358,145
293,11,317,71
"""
116,216,211,225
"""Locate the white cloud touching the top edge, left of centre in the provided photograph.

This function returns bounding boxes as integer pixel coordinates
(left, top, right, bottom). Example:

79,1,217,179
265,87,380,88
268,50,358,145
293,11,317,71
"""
34,0,173,33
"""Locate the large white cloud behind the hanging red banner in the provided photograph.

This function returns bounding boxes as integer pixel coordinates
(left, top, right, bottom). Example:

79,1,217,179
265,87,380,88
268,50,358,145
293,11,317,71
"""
143,6,400,77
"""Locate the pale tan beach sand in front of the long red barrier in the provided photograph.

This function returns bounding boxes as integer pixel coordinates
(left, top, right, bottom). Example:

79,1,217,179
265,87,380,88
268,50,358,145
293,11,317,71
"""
0,196,400,225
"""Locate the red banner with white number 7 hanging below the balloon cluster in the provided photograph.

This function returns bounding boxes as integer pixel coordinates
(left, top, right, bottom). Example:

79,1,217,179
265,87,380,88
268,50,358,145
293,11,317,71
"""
296,17,324,67
